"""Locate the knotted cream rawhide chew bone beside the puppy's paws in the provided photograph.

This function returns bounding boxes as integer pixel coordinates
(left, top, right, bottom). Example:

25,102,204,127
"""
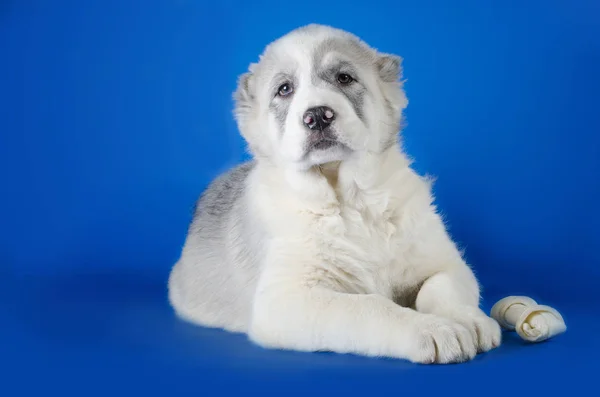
491,296,567,342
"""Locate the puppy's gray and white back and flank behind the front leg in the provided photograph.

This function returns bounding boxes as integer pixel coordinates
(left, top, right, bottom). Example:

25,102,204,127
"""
169,162,261,332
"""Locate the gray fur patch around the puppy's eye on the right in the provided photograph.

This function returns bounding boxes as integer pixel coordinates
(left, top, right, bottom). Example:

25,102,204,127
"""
311,38,373,123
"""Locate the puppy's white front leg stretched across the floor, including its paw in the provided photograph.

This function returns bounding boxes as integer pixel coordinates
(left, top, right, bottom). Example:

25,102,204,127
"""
249,249,476,363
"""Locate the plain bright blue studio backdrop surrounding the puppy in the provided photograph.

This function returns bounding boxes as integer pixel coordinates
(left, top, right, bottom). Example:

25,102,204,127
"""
0,0,600,396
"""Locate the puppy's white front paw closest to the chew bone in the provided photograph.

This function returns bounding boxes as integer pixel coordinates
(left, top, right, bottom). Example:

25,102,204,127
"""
439,306,502,353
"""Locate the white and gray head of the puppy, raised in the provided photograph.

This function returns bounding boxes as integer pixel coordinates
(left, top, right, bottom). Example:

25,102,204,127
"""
234,25,407,169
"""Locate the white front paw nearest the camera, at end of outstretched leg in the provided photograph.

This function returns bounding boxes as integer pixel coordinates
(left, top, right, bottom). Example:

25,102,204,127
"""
411,315,477,364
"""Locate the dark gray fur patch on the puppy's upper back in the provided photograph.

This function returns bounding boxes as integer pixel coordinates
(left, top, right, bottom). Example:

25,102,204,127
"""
194,161,254,217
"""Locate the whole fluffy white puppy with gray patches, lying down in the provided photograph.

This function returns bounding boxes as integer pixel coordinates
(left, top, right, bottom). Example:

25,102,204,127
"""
169,25,501,363
